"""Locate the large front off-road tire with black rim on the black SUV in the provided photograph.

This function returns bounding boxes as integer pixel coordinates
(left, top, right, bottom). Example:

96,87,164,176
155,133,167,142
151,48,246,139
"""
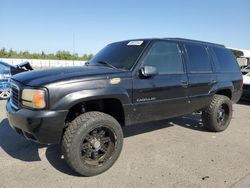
62,112,123,176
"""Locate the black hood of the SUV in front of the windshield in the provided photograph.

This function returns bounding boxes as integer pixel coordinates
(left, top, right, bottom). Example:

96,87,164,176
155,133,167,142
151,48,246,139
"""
12,66,121,86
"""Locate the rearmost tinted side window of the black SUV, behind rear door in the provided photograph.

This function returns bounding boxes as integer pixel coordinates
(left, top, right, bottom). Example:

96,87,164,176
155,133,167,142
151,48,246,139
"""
213,47,239,72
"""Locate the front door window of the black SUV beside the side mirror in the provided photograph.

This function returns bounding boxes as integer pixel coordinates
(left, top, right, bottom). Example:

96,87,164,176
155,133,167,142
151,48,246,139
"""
143,42,183,74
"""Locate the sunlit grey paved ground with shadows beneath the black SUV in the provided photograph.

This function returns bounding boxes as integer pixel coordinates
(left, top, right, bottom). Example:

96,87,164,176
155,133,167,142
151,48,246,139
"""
0,101,250,188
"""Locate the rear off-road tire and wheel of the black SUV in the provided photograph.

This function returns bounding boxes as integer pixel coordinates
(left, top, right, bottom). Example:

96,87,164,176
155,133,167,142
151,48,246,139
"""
202,95,233,132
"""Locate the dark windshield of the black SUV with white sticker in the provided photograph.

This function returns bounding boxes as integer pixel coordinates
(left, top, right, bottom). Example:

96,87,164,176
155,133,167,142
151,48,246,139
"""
89,41,147,70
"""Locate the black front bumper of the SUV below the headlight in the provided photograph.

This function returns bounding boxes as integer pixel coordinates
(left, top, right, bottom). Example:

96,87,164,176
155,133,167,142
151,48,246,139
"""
6,100,68,144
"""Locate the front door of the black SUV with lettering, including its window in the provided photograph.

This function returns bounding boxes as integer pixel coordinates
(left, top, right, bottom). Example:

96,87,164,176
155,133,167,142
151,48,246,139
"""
133,41,188,123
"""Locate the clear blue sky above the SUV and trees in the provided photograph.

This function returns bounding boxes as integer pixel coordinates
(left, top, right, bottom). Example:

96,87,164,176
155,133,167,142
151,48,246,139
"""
0,0,250,55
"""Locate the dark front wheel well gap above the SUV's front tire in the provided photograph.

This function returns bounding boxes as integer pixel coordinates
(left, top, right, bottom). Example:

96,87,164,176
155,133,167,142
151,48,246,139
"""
65,99,125,126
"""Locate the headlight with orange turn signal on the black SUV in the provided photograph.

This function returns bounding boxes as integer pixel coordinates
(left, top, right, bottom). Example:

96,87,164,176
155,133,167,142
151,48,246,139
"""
22,89,46,109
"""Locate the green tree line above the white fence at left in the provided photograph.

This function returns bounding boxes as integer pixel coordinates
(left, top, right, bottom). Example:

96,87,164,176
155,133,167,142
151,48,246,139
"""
0,48,93,61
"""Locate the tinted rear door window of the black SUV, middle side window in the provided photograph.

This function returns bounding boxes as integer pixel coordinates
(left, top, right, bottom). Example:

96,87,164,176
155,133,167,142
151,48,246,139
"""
185,44,212,72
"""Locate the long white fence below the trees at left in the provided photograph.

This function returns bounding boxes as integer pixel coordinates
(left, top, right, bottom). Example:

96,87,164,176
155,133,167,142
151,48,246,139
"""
0,58,86,68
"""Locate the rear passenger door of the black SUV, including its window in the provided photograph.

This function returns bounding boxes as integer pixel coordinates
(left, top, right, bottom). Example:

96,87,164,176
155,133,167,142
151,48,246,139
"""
183,43,217,111
